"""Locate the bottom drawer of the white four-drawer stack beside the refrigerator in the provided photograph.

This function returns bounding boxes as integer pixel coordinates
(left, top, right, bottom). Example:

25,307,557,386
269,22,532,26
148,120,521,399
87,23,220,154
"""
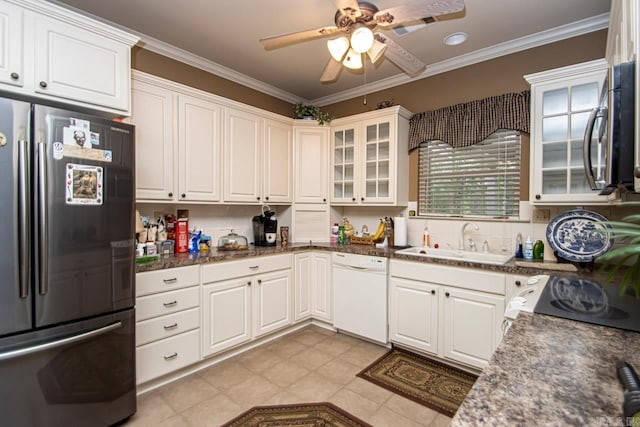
136,329,200,384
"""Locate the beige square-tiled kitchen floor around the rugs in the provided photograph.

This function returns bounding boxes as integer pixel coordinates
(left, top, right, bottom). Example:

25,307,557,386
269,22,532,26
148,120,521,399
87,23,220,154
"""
125,325,450,427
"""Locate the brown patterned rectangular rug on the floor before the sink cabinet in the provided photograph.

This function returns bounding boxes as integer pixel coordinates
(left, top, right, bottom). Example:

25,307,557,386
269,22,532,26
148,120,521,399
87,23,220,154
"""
357,348,478,417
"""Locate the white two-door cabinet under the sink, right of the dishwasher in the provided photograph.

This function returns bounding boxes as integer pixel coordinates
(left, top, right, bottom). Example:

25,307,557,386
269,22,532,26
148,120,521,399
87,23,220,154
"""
389,260,506,368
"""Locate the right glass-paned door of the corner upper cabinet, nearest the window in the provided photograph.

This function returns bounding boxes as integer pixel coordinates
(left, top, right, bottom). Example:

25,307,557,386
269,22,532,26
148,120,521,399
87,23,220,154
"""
361,121,391,203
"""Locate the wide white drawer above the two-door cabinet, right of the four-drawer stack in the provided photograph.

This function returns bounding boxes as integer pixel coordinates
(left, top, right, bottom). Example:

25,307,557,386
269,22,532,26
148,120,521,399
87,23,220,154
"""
202,254,293,283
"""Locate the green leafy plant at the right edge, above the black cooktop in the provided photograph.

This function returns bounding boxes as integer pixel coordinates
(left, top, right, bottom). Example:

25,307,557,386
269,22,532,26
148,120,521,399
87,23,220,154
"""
598,207,640,298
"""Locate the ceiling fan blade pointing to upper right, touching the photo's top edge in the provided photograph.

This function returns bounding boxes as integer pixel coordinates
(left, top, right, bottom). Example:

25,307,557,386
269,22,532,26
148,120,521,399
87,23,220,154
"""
374,0,464,28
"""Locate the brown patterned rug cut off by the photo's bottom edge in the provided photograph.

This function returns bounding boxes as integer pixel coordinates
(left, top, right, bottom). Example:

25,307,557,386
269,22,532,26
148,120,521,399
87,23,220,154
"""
222,402,372,427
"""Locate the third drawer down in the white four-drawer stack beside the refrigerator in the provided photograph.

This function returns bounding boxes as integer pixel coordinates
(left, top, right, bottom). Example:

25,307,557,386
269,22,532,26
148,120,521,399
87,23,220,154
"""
136,308,200,345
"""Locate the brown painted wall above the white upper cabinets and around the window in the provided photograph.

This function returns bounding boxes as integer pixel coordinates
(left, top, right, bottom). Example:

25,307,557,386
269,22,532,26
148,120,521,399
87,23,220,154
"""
132,30,607,200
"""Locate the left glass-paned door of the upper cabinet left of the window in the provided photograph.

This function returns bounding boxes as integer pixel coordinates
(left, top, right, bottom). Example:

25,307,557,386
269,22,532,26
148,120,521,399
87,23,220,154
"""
331,127,356,203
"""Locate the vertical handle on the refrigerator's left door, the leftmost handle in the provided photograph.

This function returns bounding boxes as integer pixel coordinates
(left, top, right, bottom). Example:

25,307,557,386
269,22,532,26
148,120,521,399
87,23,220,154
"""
18,141,31,299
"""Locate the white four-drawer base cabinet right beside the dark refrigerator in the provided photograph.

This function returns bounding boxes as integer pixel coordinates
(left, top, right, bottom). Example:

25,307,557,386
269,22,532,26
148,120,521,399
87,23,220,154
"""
136,266,200,384
